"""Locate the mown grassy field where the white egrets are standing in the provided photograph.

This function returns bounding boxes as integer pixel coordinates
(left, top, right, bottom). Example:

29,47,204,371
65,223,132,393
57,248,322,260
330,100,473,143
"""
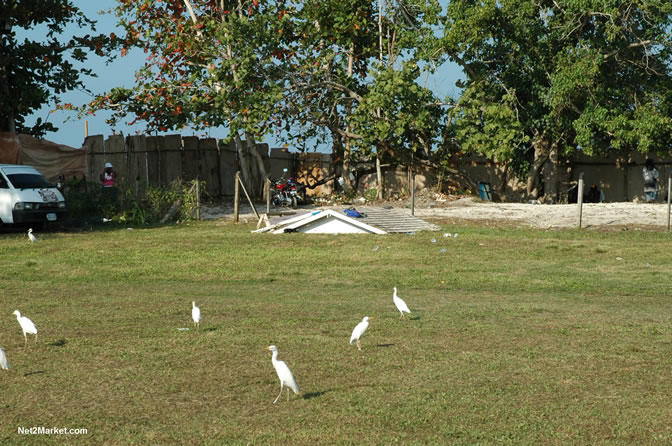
0,222,672,445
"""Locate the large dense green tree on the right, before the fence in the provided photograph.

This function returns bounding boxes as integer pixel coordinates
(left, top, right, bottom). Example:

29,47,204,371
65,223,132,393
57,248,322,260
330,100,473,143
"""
443,0,672,199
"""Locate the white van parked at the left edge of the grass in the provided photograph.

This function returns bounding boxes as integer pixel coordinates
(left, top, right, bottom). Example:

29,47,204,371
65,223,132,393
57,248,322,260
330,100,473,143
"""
0,164,65,224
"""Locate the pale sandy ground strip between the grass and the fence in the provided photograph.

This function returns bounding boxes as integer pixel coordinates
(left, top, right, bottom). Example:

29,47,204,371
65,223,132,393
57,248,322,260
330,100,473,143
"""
201,194,668,230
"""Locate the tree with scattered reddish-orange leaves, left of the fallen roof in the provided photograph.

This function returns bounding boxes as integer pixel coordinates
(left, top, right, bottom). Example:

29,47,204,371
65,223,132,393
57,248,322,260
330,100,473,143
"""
82,0,282,196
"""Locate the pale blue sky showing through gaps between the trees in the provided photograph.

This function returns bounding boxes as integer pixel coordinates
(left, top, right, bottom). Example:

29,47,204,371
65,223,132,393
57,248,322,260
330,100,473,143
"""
17,0,462,149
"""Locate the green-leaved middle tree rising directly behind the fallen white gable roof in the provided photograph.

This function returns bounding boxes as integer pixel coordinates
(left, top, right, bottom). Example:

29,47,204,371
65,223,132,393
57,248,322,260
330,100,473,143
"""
284,0,442,197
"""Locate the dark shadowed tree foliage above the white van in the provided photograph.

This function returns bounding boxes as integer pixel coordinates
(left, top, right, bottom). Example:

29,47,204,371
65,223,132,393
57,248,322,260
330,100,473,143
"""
0,0,115,136
